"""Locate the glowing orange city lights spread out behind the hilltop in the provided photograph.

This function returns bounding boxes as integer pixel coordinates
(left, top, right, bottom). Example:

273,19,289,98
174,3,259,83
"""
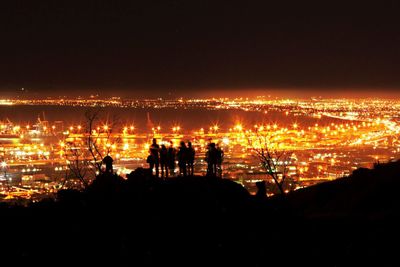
0,96,400,200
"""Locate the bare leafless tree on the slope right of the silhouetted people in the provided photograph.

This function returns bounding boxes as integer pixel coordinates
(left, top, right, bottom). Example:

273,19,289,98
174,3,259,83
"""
249,134,293,195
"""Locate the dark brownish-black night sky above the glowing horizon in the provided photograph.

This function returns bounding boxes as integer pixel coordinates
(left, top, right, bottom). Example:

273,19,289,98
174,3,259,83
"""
0,0,400,98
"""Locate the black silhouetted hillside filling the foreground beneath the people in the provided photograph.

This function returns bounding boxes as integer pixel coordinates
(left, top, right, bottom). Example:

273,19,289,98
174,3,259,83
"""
0,162,400,266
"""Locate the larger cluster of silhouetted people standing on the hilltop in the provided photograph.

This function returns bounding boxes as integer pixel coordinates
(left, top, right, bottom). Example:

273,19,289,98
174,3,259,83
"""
147,138,196,178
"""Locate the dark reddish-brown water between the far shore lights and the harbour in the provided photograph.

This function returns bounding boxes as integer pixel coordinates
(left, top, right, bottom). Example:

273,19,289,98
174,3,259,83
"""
0,106,344,131
